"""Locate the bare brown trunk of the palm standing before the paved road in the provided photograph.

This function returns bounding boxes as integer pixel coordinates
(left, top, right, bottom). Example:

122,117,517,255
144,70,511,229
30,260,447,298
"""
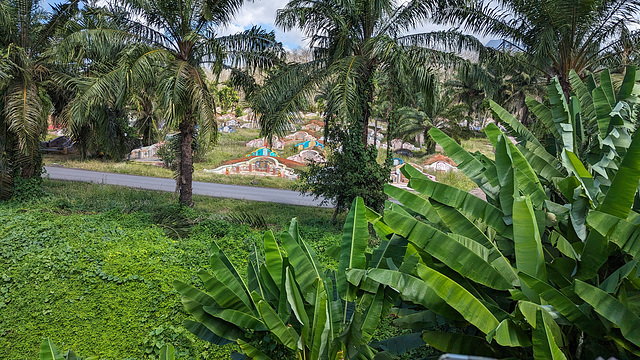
176,113,195,207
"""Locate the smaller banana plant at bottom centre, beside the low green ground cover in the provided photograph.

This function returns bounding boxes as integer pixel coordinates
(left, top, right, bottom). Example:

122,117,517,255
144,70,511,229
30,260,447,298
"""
174,198,425,360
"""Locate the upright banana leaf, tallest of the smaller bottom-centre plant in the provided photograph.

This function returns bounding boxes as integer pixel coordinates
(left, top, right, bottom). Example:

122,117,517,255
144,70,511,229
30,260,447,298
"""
337,197,369,301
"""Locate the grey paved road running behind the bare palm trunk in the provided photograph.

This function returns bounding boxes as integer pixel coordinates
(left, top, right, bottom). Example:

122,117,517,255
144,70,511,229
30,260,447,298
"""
45,166,327,207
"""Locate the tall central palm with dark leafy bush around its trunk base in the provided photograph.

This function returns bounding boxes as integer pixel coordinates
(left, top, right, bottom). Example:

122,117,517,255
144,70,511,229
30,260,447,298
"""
252,0,486,211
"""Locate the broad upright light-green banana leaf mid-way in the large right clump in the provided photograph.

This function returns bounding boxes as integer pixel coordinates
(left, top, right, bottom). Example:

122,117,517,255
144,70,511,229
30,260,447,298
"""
513,197,547,301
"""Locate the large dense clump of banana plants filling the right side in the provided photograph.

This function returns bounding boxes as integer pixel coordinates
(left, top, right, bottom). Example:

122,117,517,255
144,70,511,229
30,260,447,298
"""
346,69,640,359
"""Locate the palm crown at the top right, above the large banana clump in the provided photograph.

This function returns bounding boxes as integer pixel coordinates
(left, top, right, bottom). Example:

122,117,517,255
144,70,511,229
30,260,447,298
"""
435,0,640,96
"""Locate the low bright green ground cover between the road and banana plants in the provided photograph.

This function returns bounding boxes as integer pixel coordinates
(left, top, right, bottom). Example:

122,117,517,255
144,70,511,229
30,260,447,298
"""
0,181,344,359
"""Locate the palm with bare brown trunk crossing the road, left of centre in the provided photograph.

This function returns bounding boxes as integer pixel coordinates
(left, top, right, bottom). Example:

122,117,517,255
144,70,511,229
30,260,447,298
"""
63,0,283,206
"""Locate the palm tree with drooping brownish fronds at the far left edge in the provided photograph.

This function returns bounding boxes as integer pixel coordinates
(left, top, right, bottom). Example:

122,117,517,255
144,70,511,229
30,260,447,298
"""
0,0,77,197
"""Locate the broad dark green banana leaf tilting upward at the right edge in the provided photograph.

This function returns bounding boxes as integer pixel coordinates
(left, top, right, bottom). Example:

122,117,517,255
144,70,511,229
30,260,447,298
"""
598,131,640,219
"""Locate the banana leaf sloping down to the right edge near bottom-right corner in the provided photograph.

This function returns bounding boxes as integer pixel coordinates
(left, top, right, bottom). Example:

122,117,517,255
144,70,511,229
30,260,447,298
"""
575,280,640,346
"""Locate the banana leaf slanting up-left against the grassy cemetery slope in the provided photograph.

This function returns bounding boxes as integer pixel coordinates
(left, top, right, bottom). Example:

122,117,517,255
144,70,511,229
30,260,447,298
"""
429,127,499,198
